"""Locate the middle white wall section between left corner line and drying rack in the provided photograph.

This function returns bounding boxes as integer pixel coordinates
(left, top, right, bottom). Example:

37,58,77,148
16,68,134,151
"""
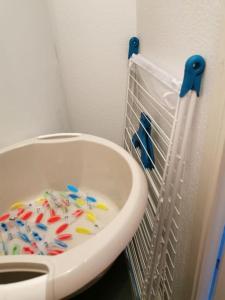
48,0,136,143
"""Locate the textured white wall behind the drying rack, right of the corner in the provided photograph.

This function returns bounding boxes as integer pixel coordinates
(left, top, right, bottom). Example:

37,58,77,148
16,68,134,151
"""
137,0,225,300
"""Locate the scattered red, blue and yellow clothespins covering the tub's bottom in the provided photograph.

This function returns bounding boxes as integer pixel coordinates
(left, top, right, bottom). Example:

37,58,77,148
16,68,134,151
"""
0,185,118,255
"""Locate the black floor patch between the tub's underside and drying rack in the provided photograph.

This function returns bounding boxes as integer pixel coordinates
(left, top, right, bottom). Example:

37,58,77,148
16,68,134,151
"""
71,255,134,300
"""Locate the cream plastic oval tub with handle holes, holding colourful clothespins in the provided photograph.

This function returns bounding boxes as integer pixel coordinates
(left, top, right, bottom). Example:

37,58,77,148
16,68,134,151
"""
0,134,147,300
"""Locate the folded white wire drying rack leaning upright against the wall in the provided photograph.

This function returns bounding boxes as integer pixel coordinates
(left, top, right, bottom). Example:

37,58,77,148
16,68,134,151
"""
124,40,205,300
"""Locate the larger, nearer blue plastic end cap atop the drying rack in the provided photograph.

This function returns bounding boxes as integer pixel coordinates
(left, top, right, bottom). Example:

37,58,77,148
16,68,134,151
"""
180,55,205,97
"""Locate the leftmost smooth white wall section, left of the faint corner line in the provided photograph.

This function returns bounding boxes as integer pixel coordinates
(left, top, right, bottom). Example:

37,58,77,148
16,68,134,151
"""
0,0,68,147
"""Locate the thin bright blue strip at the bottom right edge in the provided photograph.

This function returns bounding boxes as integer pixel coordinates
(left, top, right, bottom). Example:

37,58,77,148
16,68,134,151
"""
208,226,225,300
